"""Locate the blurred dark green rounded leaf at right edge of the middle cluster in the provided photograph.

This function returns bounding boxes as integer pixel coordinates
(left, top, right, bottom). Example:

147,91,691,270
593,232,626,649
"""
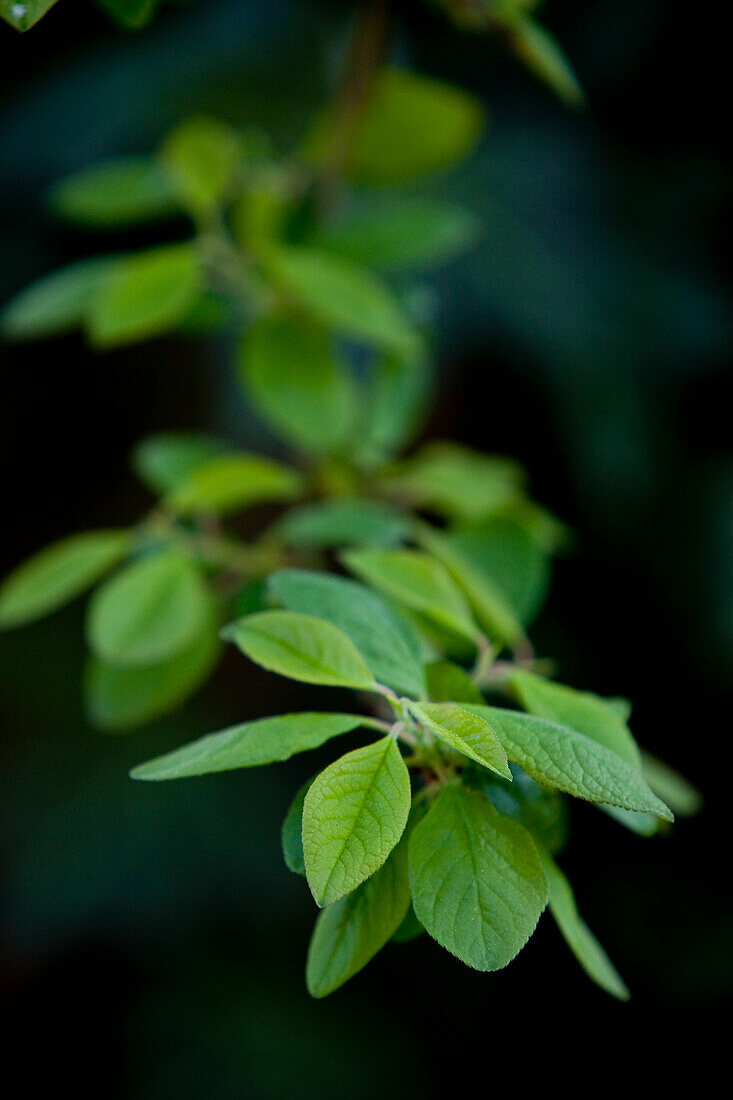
449,516,550,627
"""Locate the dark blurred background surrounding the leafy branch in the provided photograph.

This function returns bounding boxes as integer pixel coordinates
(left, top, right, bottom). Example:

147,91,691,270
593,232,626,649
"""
0,0,733,1100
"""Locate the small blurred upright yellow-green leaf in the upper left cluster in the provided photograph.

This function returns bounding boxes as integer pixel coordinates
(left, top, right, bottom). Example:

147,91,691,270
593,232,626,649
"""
161,114,243,216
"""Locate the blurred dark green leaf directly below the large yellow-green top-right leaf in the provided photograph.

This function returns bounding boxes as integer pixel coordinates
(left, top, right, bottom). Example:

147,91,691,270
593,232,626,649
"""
309,196,478,270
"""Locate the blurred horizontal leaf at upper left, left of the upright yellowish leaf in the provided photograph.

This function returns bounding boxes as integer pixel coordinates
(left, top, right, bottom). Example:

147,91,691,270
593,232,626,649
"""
48,156,178,230
